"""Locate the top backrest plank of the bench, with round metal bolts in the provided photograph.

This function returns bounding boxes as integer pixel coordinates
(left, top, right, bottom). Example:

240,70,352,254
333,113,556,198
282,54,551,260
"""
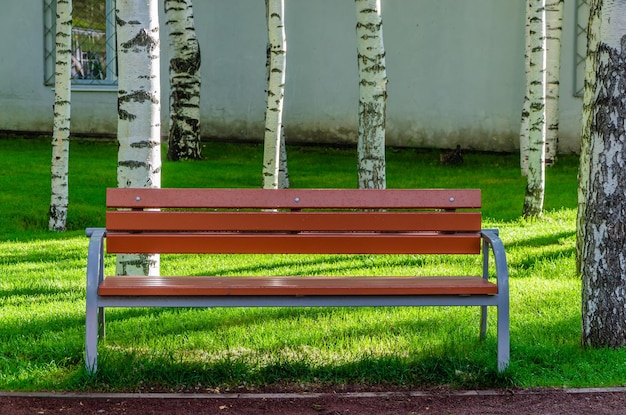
107,189,481,209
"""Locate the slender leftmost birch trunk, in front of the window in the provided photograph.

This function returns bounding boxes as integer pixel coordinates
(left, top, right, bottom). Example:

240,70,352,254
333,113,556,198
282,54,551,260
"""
48,0,72,231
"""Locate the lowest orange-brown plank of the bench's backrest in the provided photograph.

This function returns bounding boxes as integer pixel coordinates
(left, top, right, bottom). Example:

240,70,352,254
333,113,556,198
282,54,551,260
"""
107,232,480,254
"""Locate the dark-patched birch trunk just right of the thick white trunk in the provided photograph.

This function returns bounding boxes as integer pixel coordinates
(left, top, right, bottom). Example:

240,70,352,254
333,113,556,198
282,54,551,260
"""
164,0,202,161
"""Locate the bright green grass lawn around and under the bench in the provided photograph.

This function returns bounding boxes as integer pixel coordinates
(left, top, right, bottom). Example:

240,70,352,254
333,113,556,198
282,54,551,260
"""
0,138,626,392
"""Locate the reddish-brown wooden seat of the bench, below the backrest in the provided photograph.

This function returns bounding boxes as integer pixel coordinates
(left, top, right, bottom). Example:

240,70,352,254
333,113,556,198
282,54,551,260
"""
98,277,498,296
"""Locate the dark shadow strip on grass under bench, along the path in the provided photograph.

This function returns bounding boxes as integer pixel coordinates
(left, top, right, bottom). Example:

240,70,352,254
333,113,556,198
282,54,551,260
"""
88,342,514,392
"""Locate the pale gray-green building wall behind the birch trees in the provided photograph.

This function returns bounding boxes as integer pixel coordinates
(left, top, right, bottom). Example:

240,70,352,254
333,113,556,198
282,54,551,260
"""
0,0,582,152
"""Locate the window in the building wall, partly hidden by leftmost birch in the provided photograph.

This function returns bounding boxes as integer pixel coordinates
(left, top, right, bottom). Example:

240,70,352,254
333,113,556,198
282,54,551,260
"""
44,0,117,86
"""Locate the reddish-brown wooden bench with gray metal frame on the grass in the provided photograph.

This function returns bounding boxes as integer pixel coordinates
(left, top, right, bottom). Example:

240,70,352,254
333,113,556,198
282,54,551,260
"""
86,189,509,373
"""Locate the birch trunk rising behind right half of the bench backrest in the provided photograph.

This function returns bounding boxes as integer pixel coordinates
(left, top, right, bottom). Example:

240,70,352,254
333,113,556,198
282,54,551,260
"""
355,0,387,189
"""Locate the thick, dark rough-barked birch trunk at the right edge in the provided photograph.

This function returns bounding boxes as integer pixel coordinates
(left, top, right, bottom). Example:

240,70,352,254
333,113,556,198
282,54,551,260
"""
582,0,626,347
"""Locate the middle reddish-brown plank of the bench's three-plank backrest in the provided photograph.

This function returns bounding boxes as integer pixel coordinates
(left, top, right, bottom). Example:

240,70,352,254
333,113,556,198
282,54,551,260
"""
106,211,481,232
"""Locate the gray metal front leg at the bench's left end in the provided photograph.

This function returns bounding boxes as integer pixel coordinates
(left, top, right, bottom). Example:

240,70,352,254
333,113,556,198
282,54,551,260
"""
85,229,105,374
